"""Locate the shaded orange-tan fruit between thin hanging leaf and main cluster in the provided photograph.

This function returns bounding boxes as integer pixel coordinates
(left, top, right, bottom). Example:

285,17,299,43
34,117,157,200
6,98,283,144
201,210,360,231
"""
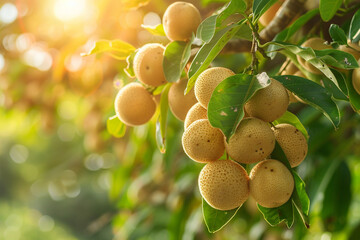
168,78,197,121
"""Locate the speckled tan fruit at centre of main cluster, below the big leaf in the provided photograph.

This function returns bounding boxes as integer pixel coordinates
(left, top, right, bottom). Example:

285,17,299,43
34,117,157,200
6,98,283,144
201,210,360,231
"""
225,118,275,164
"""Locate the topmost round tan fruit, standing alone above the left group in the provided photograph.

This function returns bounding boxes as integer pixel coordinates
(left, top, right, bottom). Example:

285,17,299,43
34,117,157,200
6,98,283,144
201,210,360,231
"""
162,2,201,41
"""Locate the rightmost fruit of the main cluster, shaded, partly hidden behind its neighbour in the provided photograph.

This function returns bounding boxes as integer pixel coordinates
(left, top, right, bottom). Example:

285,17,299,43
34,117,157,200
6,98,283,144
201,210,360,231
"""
272,123,308,167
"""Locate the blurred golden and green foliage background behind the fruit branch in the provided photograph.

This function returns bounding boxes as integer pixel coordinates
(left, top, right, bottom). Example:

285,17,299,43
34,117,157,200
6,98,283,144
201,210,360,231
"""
0,0,360,240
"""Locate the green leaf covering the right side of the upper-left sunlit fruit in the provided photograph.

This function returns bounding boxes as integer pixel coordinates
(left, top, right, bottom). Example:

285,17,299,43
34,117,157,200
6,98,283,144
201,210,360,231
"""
163,41,191,82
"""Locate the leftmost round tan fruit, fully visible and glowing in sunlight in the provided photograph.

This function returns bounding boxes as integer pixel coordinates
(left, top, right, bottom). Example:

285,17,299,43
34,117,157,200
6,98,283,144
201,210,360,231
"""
115,83,156,126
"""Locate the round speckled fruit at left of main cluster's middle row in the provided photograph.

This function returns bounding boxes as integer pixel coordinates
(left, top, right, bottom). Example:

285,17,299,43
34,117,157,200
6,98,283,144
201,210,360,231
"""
182,119,225,163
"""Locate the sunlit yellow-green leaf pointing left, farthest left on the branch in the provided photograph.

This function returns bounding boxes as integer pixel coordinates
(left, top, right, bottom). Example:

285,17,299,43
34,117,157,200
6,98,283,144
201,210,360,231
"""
81,40,136,60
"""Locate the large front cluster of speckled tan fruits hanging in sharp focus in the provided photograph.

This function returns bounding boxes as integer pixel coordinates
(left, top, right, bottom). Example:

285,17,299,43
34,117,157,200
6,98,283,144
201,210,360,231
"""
182,67,308,210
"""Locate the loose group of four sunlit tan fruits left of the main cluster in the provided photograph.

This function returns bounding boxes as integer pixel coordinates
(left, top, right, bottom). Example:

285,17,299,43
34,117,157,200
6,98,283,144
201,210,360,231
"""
115,2,201,126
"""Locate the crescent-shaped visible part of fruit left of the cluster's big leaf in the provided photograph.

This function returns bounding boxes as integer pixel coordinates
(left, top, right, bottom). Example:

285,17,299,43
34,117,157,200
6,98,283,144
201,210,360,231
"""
195,67,235,109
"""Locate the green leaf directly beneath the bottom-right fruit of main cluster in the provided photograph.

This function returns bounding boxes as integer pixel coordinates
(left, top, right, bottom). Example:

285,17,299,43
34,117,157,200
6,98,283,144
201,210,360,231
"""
257,199,294,228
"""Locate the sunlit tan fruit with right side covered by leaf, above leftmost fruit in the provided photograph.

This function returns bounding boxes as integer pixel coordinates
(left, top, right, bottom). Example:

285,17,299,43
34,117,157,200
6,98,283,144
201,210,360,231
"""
134,43,166,87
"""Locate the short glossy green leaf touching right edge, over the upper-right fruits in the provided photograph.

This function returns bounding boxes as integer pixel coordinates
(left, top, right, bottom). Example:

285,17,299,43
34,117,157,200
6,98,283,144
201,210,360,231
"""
309,49,359,69
